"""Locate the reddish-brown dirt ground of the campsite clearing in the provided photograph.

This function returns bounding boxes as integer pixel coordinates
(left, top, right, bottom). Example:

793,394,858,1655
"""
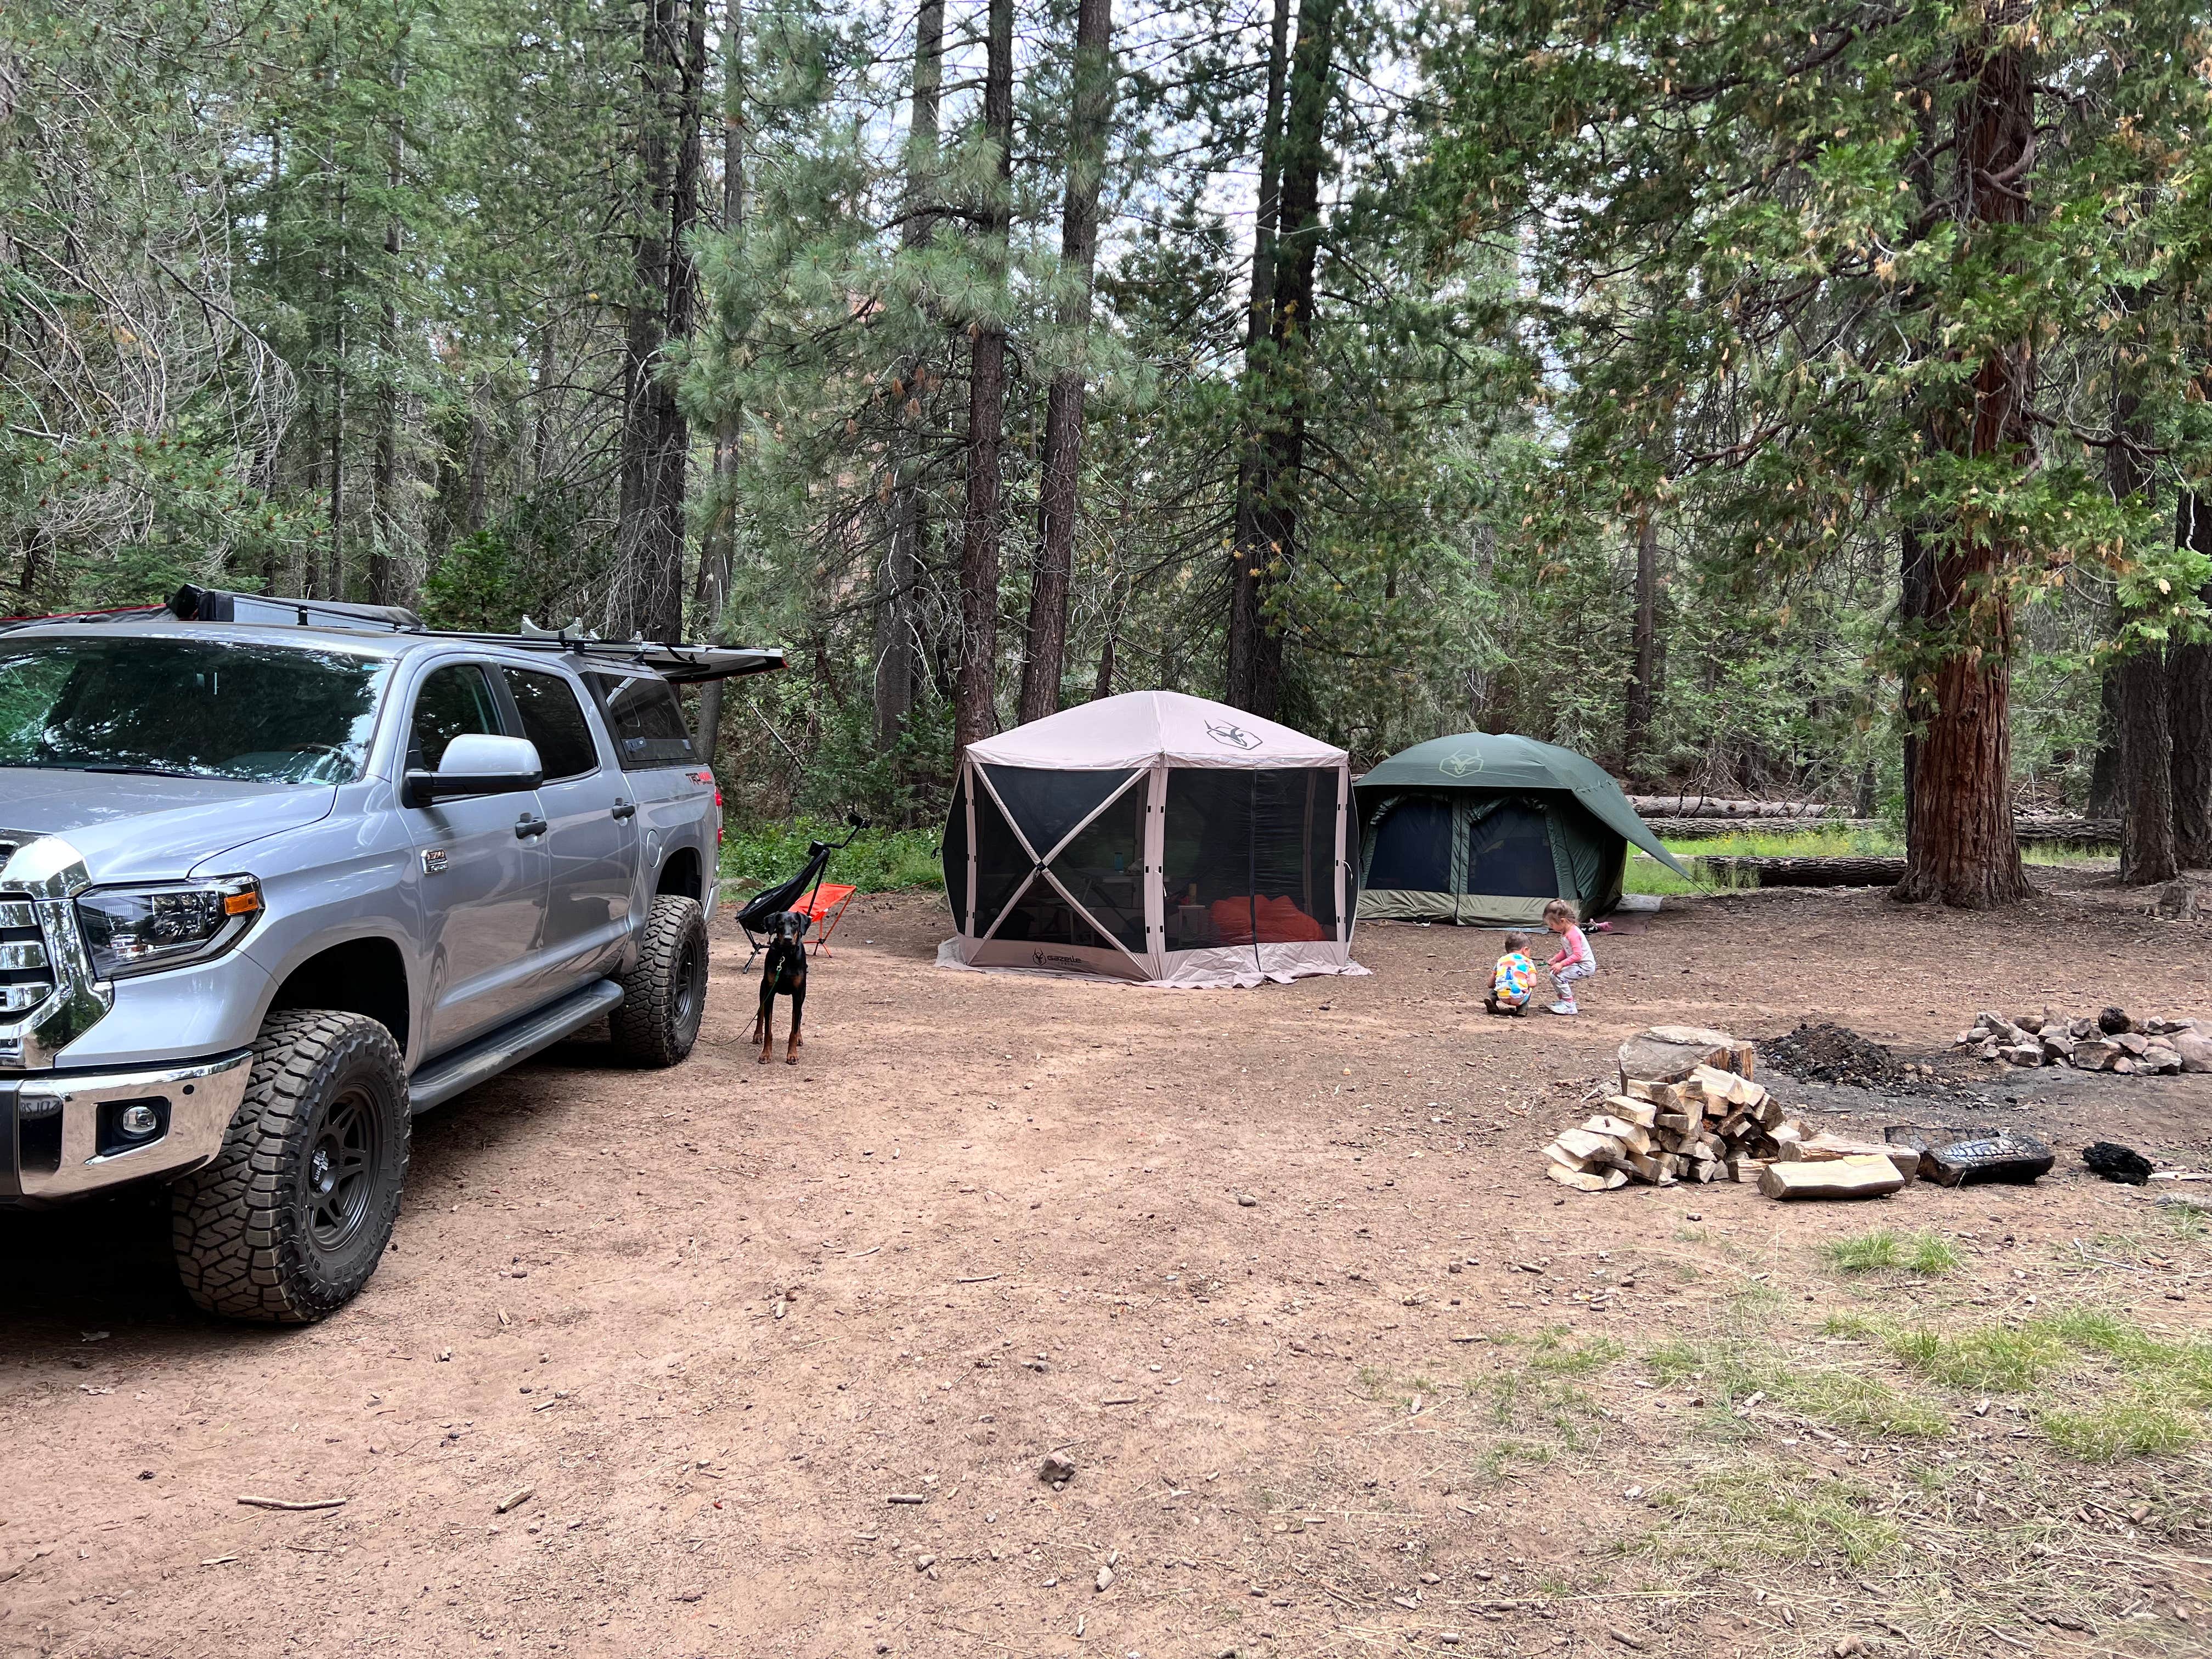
0,876,2212,1659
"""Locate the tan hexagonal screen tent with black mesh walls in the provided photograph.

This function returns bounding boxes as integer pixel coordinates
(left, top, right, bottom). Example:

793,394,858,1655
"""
938,692,1365,986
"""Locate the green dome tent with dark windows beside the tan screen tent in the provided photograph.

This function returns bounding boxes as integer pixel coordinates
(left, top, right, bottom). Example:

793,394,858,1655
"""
1356,732,1688,927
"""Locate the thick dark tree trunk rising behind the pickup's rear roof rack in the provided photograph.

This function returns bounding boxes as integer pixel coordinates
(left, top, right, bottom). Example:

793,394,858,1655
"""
608,0,706,639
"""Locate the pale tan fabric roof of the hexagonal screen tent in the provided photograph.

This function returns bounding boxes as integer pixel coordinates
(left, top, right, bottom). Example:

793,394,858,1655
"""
969,692,1345,778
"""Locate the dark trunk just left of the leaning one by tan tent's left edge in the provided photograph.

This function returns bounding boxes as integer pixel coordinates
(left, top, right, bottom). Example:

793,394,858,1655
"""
953,0,1013,754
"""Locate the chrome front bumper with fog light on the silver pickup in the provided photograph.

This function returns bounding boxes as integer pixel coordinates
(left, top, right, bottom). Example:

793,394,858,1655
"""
0,1048,252,1205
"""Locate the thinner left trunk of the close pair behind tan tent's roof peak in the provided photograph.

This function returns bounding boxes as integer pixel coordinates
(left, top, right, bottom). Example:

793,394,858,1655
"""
1223,0,1290,708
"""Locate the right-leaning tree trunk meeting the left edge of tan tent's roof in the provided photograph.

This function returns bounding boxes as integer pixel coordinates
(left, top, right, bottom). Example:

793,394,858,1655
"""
1022,0,1115,721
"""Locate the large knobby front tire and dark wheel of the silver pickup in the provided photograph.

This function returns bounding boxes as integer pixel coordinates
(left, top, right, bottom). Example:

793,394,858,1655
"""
170,1009,411,1325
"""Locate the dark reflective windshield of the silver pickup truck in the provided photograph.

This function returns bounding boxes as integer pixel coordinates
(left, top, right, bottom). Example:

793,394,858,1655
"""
0,637,390,783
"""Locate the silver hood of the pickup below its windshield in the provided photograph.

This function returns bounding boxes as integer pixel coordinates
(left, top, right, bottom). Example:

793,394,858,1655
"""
0,765,338,883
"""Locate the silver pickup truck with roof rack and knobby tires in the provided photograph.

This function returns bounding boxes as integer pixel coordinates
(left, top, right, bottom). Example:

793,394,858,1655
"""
0,589,783,1323
